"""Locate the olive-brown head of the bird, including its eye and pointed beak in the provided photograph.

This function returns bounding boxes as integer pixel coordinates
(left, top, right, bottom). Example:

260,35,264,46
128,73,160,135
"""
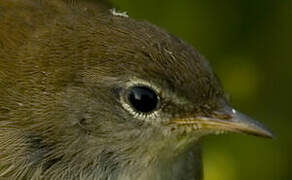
48,9,271,164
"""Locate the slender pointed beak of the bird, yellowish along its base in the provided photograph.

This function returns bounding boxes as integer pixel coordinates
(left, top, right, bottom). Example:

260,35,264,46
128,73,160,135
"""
172,107,274,138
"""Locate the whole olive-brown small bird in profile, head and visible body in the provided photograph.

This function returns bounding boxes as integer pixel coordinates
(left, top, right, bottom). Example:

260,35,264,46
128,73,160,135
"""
0,0,273,180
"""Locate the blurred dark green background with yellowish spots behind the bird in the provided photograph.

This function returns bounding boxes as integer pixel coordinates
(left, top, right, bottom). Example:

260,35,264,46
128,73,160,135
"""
112,0,292,180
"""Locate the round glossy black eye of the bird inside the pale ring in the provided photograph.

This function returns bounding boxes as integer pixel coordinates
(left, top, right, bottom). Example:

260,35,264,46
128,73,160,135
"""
128,86,158,113
